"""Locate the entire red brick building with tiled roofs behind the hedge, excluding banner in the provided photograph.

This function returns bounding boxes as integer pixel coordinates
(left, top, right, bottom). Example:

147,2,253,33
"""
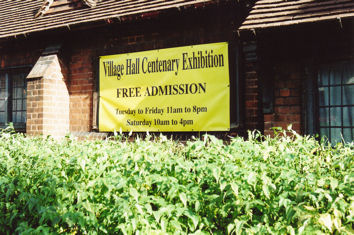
0,0,354,143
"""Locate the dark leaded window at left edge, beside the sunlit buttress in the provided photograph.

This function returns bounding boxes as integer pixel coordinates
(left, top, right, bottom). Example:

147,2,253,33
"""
0,70,27,130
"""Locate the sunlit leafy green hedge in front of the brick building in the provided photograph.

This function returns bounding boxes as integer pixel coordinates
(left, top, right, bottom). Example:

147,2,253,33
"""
0,127,354,234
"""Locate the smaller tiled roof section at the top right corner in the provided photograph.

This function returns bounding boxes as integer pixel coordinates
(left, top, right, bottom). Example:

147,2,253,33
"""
239,0,354,30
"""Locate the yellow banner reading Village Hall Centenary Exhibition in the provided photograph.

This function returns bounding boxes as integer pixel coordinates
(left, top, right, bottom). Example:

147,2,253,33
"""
99,43,230,132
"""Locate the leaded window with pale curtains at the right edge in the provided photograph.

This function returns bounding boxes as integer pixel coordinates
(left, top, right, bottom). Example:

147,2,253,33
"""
318,61,354,144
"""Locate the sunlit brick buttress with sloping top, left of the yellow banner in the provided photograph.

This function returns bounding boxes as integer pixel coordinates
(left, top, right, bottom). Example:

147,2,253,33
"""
26,55,69,137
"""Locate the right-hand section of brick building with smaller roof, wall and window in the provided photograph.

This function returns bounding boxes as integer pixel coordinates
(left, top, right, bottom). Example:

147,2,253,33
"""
239,0,354,143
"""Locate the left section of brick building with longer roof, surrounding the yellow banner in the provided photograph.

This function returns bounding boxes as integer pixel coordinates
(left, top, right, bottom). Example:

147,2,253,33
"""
0,0,253,139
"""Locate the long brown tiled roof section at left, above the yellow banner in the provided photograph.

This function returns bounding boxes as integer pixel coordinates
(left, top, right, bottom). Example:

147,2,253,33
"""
0,0,213,38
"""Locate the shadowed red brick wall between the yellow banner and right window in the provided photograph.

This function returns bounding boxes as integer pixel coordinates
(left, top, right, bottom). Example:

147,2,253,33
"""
243,35,304,135
